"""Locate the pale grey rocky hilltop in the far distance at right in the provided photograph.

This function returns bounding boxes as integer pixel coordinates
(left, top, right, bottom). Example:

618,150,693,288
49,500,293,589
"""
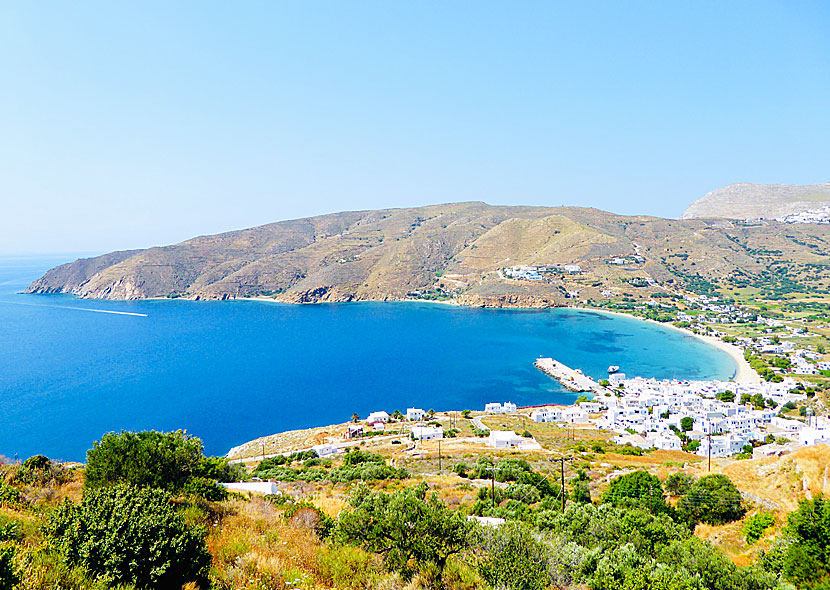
681,182,830,219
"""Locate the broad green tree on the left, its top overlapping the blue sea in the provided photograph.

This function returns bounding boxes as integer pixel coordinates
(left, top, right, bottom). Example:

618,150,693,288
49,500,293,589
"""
86,430,234,500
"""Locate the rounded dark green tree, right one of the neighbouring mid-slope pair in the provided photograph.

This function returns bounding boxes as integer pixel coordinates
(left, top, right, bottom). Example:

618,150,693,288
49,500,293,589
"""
678,473,746,525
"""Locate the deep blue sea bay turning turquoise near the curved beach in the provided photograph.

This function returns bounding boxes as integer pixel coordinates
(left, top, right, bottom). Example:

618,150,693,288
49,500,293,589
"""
0,257,736,460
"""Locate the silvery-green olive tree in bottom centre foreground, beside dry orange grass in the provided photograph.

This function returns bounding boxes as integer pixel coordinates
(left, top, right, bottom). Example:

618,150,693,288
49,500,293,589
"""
336,483,471,579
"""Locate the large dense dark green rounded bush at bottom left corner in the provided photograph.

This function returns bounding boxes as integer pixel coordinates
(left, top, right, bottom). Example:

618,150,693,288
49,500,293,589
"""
46,485,211,589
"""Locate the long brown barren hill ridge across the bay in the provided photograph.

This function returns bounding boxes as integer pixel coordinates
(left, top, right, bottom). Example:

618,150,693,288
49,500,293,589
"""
27,202,830,307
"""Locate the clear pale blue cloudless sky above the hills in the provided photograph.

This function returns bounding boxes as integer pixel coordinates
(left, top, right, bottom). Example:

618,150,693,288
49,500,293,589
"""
0,0,830,253
